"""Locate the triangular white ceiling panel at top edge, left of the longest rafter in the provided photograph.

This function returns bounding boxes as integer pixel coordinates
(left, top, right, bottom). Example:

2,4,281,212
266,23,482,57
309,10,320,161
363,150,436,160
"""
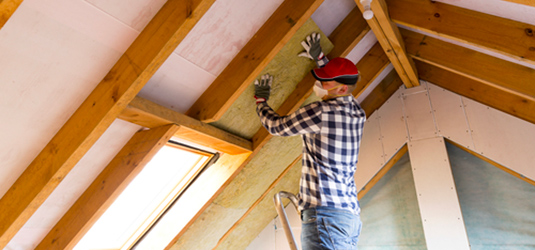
85,0,167,32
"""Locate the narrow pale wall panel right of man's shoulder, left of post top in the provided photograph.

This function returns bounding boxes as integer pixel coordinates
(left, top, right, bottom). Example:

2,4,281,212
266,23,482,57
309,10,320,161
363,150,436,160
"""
377,89,408,161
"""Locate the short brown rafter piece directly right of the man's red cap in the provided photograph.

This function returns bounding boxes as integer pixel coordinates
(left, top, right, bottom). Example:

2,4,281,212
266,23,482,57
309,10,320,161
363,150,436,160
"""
353,43,390,98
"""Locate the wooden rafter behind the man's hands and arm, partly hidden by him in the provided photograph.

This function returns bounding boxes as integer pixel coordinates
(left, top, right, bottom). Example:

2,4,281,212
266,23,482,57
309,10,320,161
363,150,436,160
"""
252,7,370,150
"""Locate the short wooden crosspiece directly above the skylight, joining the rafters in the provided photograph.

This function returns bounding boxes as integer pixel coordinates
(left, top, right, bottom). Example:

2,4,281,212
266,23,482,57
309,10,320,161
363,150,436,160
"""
119,96,253,154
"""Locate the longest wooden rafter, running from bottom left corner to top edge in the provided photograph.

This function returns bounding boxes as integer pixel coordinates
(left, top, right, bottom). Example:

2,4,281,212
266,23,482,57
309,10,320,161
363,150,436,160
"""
0,0,215,248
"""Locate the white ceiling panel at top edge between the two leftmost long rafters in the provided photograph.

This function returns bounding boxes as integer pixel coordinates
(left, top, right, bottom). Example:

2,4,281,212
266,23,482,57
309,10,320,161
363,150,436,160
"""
175,0,283,76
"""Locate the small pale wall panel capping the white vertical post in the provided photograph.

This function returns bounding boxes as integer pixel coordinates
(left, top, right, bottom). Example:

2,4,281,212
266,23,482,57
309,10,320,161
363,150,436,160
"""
401,83,438,141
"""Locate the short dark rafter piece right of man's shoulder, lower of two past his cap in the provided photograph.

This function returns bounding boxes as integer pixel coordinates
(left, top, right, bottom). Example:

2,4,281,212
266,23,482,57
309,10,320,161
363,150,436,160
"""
360,70,403,117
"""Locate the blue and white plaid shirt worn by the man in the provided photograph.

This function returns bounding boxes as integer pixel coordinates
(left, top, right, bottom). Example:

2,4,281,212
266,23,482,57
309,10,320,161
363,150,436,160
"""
256,95,366,214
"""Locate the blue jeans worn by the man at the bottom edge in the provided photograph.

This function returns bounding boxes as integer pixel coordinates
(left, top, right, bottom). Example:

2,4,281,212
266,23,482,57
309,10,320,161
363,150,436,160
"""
301,207,362,250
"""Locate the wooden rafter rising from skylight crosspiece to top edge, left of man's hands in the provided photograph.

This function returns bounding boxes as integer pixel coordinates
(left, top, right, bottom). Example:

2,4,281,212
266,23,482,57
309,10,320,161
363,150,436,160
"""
186,0,323,122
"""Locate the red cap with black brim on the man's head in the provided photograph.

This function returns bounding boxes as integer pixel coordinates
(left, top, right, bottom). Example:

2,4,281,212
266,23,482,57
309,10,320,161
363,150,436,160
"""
312,57,359,85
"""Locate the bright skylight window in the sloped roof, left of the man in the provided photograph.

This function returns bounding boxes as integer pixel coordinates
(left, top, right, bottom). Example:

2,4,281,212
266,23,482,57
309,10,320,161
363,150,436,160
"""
74,143,213,250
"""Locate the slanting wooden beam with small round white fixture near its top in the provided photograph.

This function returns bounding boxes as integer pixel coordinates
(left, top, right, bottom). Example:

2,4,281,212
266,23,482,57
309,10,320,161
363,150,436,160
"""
355,0,420,88
